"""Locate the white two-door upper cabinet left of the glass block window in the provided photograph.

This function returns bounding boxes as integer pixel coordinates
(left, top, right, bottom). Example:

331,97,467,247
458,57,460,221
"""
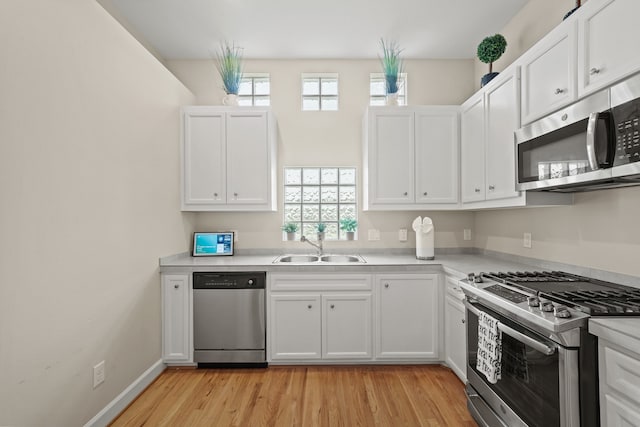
182,107,276,211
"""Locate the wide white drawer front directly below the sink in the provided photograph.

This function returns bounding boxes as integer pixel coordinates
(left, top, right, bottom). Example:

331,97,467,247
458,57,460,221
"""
270,273,371,291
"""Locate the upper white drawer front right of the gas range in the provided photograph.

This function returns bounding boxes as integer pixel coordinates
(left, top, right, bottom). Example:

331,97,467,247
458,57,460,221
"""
600,344,640,405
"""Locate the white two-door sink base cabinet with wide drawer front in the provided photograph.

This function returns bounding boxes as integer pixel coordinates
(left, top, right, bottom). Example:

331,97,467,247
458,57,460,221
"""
267,274,372,361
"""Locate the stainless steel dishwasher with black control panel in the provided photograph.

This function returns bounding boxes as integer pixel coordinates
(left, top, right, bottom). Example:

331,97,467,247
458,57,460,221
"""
193,272,267,367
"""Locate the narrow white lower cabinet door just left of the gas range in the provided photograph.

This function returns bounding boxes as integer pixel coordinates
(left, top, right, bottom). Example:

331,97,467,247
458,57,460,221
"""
444,295,467,381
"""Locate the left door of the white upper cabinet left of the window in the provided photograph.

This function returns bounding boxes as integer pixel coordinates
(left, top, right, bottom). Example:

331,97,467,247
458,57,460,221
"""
182,108,227,209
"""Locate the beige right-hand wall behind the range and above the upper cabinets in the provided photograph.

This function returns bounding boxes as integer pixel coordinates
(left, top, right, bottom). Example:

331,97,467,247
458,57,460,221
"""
475,0,640,276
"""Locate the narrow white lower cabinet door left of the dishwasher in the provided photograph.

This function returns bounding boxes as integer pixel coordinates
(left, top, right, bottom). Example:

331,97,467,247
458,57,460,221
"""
162,274,192,362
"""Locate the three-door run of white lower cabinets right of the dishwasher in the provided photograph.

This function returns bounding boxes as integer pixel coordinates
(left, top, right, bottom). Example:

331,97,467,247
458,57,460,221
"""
267,273,442,363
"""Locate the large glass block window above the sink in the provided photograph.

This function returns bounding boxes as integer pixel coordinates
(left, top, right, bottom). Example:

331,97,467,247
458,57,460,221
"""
284,167,358,240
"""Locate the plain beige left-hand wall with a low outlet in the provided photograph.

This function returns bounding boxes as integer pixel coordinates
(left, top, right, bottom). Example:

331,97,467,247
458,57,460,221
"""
0,0,193,427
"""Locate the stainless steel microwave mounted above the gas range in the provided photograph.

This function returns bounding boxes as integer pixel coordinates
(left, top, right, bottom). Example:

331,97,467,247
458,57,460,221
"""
515,74,640,192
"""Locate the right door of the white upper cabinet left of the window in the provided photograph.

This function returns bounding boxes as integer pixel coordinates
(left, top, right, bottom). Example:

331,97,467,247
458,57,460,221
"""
226,112,273,205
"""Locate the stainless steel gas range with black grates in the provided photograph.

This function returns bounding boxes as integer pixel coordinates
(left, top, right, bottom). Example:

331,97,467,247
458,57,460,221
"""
460,271,640,427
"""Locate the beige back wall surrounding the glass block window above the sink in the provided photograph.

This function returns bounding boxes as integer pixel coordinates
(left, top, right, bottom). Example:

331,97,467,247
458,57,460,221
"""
167,60,474,249
